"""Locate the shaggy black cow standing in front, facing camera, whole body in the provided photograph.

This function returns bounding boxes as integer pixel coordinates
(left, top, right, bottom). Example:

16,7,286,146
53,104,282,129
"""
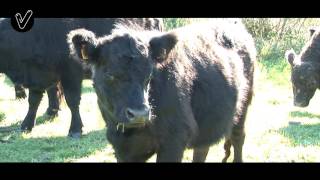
68,20,256,162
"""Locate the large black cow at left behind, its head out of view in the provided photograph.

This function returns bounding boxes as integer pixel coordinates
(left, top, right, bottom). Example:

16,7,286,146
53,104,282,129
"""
0,18,162,137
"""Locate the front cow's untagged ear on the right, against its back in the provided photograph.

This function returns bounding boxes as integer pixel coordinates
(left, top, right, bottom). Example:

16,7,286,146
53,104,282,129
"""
149,33,178,63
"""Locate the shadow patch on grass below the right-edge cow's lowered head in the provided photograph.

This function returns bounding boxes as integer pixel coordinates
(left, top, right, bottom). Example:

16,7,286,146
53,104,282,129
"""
278,124,320,146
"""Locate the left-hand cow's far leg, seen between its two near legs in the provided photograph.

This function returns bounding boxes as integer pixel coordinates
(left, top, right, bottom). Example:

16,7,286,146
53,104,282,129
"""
46,85,60,117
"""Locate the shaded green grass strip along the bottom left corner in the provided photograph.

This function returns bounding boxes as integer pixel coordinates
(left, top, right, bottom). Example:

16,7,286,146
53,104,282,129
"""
0,129,108,162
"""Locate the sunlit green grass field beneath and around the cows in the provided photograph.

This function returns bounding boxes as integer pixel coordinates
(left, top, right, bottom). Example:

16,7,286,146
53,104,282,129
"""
0,60,320,162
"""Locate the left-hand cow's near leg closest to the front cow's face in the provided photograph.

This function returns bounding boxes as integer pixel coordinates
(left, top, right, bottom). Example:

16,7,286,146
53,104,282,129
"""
61,76,83,138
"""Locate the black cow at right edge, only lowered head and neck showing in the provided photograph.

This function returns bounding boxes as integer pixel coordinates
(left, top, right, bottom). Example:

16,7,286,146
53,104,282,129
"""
285,28,320,107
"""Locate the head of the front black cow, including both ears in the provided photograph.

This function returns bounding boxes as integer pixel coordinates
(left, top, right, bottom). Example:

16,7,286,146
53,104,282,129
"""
68,29,175,129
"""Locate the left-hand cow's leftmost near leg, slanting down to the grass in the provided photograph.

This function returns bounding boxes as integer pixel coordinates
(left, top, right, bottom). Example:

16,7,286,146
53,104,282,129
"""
21,89,44,131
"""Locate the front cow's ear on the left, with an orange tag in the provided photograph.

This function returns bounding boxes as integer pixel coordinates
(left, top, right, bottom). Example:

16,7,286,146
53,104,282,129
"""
67,29,99,63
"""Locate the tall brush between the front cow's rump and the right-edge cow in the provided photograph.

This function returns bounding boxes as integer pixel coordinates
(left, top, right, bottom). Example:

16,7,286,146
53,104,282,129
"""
242,18,320,65
